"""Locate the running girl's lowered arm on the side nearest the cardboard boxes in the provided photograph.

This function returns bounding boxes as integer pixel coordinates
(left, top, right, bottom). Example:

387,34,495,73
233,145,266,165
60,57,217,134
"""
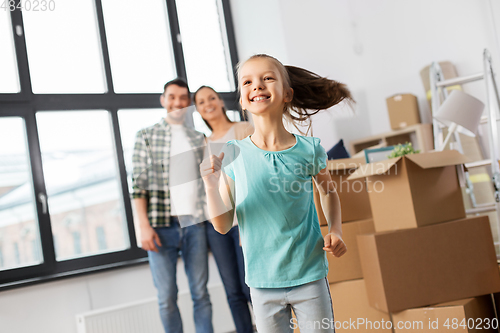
314,168,347,257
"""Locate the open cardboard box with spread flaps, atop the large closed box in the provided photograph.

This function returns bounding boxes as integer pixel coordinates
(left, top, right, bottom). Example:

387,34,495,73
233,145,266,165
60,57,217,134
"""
349,150,468,232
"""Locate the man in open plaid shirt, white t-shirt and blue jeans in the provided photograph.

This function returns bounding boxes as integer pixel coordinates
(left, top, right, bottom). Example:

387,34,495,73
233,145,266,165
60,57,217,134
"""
132,79,213,333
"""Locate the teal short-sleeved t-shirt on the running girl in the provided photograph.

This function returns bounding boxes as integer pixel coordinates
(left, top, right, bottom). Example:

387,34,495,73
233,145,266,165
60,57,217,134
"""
222,135,328,288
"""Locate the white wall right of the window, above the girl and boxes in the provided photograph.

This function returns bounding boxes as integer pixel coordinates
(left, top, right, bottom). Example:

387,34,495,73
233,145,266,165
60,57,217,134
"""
231,0,500,149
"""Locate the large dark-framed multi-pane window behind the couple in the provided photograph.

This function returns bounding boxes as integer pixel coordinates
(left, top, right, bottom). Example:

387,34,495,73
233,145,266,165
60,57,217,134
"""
0,0,239,289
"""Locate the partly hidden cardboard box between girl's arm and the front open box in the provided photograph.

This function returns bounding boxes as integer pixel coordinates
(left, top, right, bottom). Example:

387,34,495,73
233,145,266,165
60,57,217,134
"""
328,157,372,222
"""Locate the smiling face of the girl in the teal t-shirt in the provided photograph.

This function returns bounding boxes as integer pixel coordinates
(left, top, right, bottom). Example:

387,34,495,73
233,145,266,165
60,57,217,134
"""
239,58,293,114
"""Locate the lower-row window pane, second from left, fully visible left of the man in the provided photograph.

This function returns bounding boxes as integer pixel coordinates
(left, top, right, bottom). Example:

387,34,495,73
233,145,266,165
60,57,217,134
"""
36,111,129,261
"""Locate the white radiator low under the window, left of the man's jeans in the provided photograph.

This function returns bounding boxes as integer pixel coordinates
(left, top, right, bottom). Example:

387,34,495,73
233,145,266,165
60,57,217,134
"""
76,297,164,333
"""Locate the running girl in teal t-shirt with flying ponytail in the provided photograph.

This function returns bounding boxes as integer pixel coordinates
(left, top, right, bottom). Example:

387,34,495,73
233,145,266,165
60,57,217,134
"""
200,55,352,333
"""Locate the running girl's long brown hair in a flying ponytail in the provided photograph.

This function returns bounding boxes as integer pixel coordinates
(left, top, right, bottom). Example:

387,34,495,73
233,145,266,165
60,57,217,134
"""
238,54,354,132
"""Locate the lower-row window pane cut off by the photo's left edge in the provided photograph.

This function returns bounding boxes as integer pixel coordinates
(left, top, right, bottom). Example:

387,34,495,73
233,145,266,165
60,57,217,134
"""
0,117,43,270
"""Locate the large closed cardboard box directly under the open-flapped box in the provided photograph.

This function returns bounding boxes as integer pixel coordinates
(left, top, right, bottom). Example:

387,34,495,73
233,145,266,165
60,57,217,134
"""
358,216,500,312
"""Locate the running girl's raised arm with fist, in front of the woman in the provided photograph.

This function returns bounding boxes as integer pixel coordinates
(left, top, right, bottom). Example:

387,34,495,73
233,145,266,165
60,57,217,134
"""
200,153,235,234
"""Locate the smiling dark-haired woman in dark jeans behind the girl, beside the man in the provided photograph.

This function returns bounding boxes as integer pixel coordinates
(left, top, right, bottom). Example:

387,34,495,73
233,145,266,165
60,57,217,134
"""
193,86,253,333
